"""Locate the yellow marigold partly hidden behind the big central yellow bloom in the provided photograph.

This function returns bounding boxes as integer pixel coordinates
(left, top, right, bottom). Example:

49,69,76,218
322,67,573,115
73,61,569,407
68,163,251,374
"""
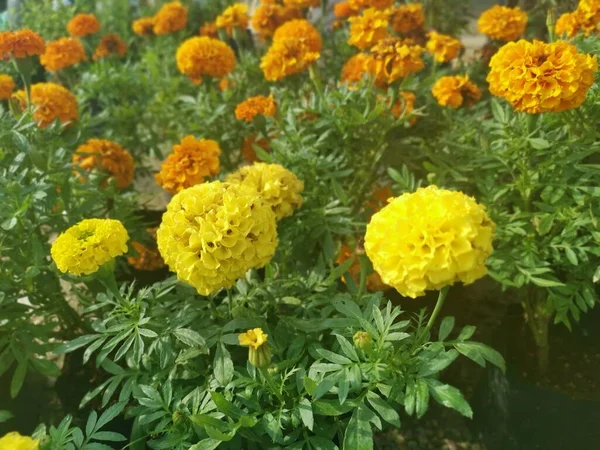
227,163,304,220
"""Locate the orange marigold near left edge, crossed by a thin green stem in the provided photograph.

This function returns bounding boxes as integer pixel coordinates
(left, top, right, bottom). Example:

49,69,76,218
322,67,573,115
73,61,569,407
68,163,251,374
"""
14,83,79,128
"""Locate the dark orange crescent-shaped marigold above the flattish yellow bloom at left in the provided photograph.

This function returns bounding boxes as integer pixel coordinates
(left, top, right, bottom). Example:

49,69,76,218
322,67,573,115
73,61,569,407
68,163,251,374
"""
73,139,134,189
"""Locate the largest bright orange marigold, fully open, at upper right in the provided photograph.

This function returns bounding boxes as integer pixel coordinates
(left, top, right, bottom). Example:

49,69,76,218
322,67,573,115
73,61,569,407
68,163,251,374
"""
487,40,598,114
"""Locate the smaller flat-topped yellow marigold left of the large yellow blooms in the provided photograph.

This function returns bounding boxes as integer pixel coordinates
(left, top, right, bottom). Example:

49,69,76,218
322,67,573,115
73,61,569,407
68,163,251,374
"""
50,219,129,275
